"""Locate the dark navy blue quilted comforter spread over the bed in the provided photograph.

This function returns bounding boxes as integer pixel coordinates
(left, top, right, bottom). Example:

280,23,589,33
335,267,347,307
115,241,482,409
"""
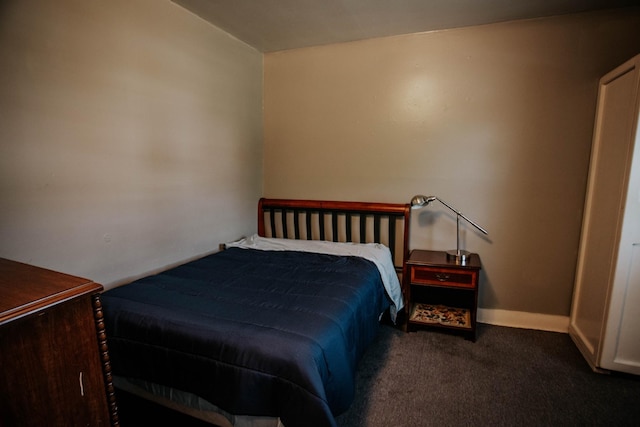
101,248,389,427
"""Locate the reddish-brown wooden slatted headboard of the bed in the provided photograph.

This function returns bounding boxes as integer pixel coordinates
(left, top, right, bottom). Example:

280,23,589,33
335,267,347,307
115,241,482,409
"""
258,198,410,272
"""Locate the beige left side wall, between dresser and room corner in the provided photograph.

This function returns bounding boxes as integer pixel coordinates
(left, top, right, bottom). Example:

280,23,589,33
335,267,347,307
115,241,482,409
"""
0,0,262,287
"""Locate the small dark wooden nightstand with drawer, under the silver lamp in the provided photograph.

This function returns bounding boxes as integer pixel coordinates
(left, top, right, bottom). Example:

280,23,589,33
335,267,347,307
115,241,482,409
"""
404,250,482,341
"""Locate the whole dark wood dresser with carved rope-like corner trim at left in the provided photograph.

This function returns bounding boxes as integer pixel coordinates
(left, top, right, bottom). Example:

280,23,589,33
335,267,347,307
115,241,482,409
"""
0,258,119,426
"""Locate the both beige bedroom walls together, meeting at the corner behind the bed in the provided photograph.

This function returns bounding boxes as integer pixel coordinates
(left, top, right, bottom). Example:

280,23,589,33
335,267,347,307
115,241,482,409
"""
5,0,640,315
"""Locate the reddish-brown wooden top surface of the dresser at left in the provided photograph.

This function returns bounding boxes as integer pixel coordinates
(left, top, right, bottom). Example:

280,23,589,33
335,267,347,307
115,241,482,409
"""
0,258,102,324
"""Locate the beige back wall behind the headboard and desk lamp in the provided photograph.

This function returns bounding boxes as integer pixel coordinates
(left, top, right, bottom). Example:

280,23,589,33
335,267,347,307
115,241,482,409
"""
264,9,640,316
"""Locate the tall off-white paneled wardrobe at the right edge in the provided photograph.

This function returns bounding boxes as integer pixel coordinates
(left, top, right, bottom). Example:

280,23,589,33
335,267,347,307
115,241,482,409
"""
569,52,640,374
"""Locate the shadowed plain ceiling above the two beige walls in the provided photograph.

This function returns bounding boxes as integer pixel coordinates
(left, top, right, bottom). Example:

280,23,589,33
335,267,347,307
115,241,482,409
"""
172,0,640,52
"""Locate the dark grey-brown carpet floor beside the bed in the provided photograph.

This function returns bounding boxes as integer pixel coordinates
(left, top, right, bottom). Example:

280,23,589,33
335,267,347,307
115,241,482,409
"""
337,324,640,427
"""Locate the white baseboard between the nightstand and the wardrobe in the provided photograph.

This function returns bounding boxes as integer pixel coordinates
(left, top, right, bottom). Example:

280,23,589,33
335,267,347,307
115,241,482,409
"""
477,308,569,334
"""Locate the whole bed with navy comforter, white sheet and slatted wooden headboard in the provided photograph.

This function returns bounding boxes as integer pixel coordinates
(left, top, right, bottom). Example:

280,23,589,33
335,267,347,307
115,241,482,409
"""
101,199,409,427
